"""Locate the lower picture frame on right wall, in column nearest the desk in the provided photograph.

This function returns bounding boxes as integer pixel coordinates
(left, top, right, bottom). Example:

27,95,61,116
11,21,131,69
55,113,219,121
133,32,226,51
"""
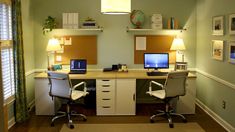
212,40,224,61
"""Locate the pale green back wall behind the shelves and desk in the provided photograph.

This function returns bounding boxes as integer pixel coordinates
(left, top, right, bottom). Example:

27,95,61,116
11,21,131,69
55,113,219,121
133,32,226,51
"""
32,0,196,69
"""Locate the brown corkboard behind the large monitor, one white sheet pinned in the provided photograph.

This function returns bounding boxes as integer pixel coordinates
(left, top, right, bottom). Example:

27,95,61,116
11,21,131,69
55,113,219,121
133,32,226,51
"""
134,35,176,64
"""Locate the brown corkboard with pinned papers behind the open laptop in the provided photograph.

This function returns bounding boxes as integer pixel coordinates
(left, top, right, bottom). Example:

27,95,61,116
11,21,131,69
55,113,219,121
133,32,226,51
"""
54,35,97,64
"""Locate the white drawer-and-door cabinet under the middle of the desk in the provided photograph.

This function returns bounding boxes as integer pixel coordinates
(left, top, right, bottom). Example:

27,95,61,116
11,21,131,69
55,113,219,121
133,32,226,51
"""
96,79,136,115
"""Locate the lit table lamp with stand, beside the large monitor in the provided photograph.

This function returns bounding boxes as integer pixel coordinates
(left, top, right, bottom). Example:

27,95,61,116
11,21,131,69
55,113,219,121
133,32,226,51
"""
170,37,185,62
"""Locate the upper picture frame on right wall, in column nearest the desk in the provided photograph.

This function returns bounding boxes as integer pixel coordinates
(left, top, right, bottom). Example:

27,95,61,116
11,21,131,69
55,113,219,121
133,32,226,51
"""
212,16,224,35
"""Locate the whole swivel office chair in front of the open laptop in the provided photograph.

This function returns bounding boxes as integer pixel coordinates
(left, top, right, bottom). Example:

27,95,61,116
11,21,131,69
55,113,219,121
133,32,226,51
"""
48,71,88,129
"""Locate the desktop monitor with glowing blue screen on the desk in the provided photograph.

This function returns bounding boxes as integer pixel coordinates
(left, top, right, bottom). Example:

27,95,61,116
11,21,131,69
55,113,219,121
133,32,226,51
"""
144,53,169,70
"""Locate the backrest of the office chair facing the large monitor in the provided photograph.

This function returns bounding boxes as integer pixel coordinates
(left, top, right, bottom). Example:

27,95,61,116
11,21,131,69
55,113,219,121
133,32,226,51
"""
165,71,189,97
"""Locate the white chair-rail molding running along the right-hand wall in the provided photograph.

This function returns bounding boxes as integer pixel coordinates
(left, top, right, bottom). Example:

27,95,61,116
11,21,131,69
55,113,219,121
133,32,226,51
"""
196,69,235,89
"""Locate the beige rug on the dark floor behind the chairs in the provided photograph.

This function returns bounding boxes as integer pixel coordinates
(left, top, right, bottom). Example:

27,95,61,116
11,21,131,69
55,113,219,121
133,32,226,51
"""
60,123,205,132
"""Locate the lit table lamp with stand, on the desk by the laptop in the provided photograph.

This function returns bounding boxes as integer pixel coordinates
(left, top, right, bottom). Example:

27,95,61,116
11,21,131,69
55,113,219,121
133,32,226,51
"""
46,38,61,70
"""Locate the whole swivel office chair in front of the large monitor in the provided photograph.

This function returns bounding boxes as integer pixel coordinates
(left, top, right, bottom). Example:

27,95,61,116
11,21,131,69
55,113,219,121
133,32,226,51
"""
147,71,189,128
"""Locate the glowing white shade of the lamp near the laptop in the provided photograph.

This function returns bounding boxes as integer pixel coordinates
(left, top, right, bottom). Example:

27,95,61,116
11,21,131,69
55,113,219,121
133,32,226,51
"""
46,38,61,52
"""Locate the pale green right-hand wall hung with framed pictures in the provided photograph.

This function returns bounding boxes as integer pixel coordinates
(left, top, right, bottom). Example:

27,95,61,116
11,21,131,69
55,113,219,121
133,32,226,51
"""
196,0,235,127
